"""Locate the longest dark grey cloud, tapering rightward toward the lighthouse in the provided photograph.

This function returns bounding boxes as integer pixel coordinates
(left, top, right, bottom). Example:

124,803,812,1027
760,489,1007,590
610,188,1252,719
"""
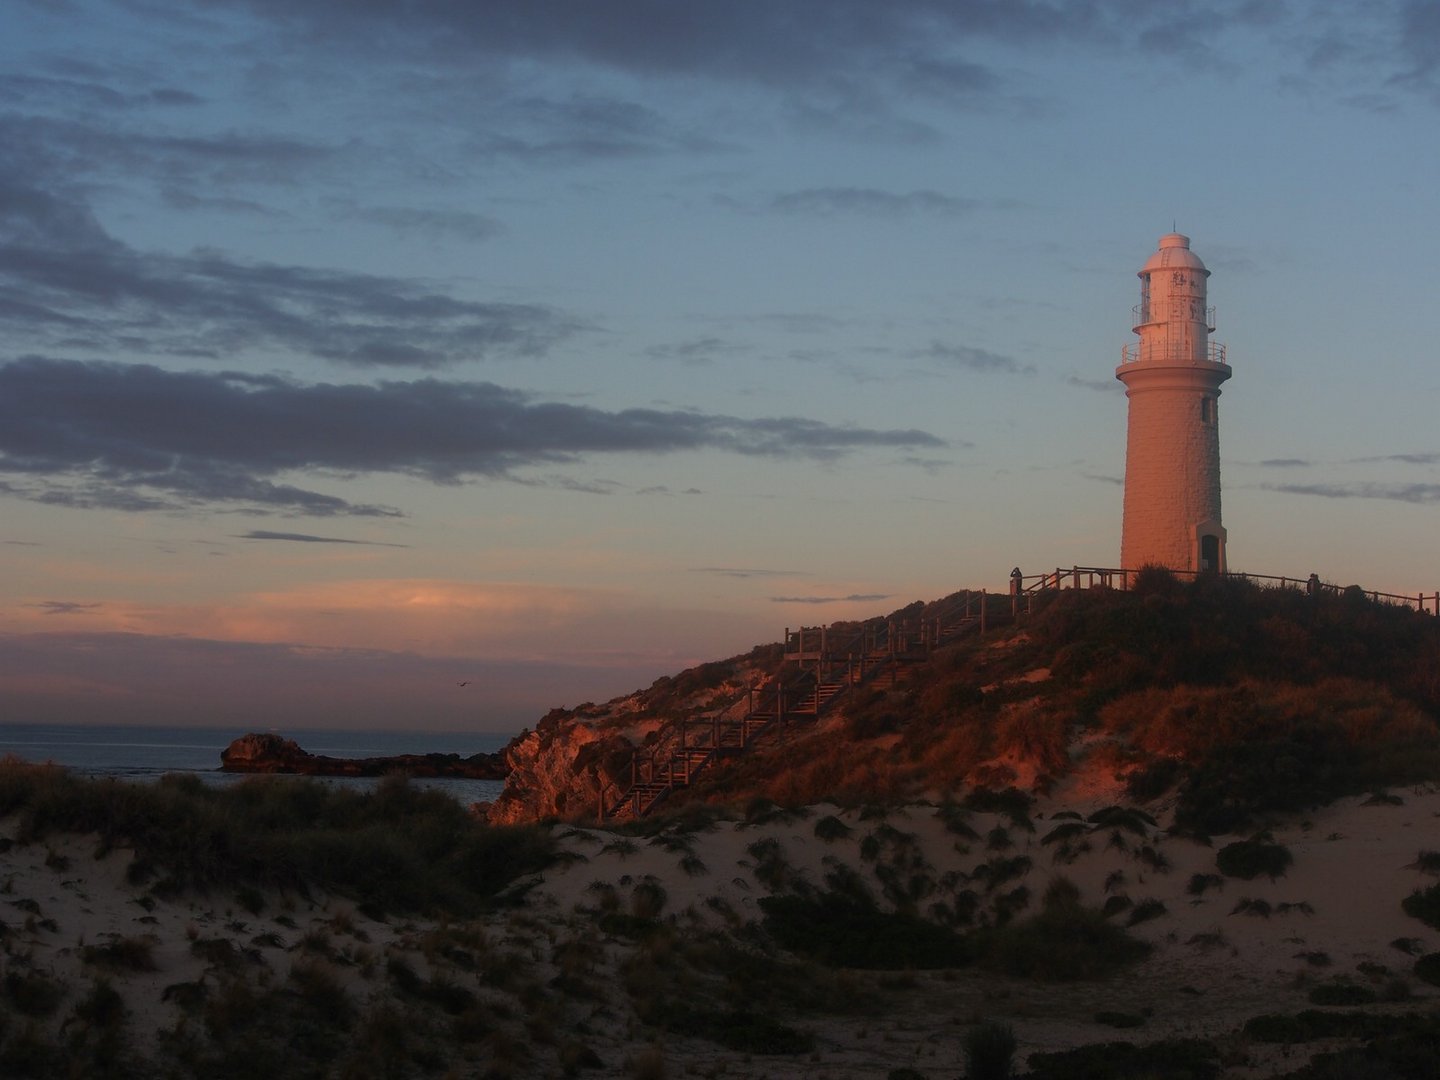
0,357,948,517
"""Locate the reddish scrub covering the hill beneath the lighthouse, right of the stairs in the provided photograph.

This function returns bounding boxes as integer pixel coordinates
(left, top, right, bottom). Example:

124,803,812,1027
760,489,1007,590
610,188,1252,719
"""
653,572,1440,834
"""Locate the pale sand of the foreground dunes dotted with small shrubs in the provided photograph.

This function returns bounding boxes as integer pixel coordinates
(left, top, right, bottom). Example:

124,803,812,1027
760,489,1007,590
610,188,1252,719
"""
0,783,1440,1077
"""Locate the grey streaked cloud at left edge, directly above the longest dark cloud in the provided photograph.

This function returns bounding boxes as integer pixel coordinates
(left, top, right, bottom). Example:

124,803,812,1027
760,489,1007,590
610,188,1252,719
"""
0,205,582,369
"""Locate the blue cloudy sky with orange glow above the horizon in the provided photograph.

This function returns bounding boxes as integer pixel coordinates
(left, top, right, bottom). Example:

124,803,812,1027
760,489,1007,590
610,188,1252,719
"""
0,0,1440,743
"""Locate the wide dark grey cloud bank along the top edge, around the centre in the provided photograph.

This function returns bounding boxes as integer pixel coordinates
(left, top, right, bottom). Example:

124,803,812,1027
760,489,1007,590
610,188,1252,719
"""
216,0,1025,94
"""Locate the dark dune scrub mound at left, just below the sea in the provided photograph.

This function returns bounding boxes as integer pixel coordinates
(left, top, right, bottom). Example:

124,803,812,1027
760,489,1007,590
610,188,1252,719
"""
0,759,553,914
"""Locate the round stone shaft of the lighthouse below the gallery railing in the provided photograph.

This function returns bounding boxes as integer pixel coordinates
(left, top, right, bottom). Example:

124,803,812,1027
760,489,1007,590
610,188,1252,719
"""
1115,360,1230,573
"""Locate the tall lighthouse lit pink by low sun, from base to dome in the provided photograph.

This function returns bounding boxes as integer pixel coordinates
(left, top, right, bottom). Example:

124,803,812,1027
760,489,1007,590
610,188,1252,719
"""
1115,232,1230,572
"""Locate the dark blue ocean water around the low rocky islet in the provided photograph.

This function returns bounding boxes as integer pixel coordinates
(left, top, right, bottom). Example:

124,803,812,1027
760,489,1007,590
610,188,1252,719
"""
0,723,510,805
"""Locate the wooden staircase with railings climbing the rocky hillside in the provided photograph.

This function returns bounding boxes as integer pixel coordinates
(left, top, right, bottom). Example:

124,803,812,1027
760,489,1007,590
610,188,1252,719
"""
599,592,1009,822
